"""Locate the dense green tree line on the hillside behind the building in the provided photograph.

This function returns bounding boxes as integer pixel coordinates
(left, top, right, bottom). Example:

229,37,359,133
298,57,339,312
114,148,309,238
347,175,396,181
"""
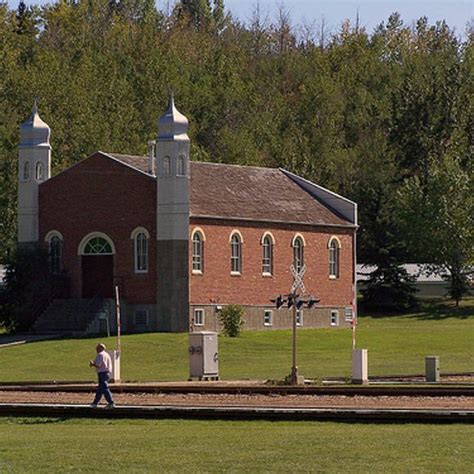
0,0,474,306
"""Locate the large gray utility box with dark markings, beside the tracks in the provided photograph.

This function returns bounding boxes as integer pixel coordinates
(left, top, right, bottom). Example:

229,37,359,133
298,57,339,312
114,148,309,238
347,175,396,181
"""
189,331,219,380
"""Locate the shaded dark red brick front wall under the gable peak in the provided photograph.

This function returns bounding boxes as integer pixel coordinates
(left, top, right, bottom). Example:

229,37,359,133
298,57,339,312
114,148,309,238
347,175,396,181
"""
39,153,156,304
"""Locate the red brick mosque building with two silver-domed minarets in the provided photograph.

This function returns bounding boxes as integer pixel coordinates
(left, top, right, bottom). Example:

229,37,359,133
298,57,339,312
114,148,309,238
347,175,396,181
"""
18,100,357,332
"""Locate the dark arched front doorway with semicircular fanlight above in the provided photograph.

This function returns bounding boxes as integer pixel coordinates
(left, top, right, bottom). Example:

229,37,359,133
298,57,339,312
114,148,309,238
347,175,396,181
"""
79,233,115,298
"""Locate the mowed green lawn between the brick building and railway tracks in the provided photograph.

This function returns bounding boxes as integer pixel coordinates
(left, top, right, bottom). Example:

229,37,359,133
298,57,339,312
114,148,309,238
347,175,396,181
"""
0,299,474,381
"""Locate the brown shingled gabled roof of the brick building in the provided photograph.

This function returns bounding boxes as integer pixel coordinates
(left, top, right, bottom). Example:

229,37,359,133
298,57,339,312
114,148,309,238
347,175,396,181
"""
107,153,354,227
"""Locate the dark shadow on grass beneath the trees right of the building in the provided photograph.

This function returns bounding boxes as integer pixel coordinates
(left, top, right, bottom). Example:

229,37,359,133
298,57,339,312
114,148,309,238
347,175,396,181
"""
361,298,474,321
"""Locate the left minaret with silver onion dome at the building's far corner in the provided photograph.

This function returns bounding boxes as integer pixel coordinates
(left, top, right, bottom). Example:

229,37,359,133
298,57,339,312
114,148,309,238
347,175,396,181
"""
18,100,51,247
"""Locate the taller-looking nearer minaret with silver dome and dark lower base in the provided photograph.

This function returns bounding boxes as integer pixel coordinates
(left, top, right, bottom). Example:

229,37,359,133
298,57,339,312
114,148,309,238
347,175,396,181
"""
156,96,189,332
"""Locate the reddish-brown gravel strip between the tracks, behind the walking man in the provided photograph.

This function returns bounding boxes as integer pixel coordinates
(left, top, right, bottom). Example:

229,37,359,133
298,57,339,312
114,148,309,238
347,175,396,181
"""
0,391,474,410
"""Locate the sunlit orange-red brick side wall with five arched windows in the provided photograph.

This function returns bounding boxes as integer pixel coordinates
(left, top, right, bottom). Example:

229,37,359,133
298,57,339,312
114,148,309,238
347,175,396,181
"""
189,218,353,306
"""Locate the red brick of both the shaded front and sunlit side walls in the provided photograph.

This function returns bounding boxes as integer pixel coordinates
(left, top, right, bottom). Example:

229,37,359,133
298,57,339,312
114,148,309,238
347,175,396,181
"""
39,154,353,314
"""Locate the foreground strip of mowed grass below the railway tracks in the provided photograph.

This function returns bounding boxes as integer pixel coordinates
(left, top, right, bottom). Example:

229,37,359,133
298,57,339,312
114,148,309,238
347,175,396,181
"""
0,418,474,473
